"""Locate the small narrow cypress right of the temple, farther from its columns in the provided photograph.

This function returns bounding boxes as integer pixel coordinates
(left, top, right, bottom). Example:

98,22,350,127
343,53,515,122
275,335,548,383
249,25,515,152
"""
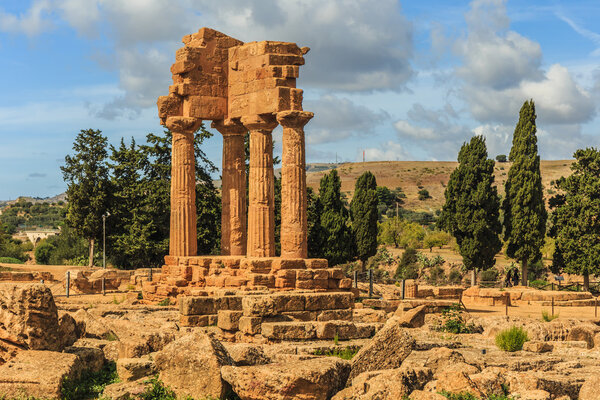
350,171,378,262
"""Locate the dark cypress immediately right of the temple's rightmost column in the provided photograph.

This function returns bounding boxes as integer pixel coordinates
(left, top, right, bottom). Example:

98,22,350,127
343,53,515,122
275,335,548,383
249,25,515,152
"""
319,169,354,266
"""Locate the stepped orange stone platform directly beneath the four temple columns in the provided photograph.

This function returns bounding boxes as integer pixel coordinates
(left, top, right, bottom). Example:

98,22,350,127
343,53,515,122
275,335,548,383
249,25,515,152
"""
142,256,352,301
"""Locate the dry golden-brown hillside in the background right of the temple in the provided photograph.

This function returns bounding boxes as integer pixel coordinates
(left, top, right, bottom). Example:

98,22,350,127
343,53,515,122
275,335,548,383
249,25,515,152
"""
306,160,572,212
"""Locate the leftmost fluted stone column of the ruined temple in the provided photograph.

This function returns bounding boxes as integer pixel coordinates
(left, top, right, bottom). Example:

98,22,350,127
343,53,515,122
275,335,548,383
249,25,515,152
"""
165,117,202,256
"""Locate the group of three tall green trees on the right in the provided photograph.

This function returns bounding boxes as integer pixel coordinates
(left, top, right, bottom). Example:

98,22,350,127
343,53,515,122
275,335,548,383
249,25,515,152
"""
438,100,600,289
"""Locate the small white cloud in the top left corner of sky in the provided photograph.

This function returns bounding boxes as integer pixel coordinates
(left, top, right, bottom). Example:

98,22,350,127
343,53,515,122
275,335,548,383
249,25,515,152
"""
0,0,53,37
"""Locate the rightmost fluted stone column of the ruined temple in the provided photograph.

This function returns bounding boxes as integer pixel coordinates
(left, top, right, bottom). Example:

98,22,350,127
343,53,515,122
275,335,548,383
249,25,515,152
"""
277,111,314,258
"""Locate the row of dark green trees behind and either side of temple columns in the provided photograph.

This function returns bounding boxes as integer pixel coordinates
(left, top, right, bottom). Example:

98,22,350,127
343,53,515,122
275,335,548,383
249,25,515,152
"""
45,127,378,268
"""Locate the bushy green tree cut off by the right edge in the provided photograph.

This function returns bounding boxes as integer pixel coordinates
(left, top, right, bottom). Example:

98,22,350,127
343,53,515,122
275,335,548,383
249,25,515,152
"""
549,148,600,290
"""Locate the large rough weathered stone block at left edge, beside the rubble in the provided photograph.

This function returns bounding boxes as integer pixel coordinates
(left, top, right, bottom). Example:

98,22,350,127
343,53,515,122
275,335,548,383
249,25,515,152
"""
0,283,65,351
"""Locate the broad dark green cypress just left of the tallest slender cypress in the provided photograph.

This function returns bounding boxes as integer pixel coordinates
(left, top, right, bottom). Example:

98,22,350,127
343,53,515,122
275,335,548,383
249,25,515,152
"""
439,136,502,280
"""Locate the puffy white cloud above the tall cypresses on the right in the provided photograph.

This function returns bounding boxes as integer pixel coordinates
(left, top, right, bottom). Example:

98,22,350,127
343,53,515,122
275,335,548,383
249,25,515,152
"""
455,0,596,125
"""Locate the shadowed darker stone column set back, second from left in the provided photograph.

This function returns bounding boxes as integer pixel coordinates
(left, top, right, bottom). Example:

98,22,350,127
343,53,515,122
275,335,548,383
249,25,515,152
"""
212,121,247,256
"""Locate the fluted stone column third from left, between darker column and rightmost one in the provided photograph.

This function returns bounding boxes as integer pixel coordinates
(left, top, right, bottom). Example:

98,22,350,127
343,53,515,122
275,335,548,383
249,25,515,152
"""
242,115,277,257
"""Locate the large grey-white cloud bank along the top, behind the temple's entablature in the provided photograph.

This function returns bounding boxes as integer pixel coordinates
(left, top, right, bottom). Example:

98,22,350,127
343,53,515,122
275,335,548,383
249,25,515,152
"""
0,0,413,118
